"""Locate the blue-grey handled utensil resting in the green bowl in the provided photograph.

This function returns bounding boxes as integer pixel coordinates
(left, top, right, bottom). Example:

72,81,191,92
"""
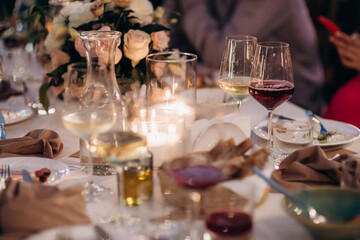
253,166,329,224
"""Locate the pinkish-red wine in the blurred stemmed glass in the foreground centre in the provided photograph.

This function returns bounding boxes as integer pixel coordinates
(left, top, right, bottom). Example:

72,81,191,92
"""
172,165,222,190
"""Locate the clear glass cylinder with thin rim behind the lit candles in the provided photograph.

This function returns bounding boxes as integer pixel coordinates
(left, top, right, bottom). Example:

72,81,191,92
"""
146,52,197,126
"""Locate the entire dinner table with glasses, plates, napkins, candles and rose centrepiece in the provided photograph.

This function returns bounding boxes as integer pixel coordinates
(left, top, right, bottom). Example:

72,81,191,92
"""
0,0,360,240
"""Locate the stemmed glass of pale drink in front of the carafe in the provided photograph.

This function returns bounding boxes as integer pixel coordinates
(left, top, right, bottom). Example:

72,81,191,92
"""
62,63,116,201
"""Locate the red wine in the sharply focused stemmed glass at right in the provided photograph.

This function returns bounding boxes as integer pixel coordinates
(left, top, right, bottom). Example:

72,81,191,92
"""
249,80,294,110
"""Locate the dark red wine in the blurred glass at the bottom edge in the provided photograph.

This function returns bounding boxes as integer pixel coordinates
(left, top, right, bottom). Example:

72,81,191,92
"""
206,210,253,237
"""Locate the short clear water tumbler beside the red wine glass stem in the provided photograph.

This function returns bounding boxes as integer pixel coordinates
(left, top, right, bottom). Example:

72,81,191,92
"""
273,120,313,169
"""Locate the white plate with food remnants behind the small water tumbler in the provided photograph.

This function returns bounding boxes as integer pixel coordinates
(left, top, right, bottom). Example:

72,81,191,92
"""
253,119,360,147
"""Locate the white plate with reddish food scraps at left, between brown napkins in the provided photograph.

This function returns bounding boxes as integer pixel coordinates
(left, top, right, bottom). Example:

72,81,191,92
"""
0,157,69,185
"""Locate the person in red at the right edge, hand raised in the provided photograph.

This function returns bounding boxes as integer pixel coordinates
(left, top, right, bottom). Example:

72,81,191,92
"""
324,32,360,127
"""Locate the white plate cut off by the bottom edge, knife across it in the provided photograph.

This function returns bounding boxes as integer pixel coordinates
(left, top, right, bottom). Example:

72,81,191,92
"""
26,225,147,240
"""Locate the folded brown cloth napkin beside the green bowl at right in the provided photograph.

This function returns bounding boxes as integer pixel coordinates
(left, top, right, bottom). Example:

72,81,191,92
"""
271,146,353,190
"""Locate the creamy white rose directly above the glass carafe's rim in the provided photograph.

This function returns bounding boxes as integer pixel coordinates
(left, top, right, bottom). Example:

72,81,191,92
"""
69,3,97,28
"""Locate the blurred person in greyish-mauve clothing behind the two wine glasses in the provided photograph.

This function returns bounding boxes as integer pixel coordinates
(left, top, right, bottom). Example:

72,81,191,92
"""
164,0,324,113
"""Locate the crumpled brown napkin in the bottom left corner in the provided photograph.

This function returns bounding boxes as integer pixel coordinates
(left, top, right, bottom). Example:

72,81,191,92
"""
0,181,90,239
